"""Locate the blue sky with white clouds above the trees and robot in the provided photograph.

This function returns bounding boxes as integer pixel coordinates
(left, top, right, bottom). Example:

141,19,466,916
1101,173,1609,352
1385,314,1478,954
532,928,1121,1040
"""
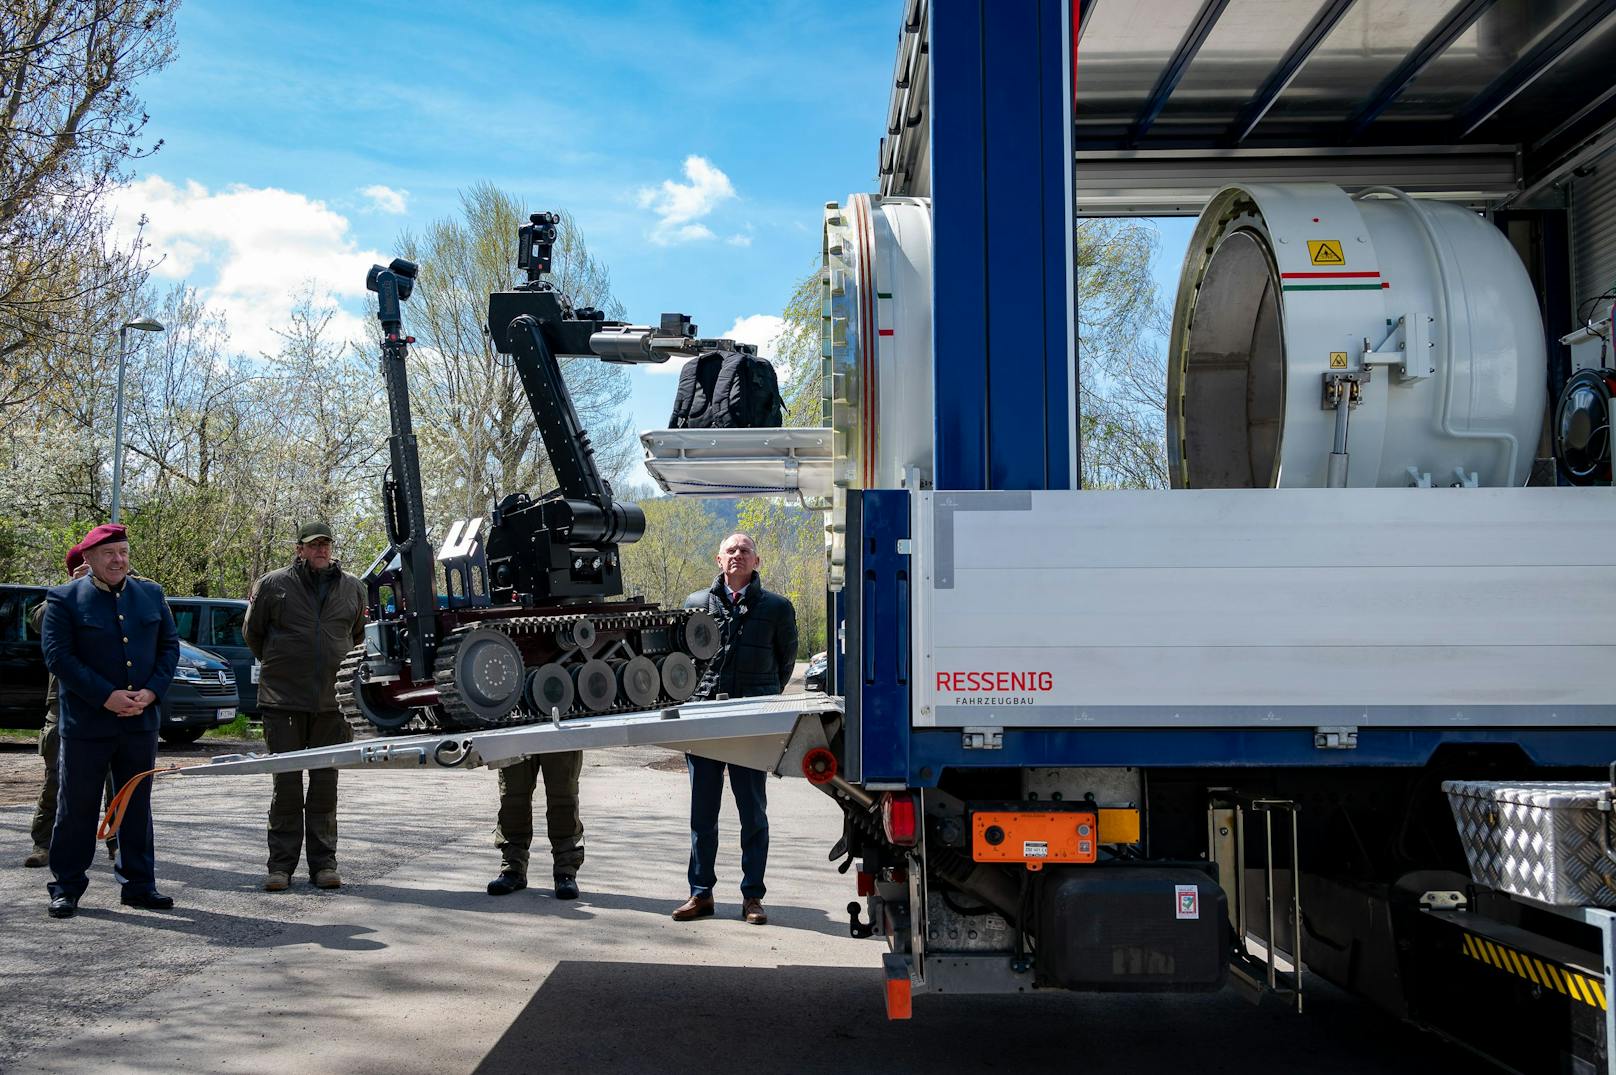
116,0,1188,478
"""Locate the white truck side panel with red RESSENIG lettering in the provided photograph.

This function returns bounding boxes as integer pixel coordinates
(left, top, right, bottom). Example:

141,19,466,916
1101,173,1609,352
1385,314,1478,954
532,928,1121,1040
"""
913,488,1616,727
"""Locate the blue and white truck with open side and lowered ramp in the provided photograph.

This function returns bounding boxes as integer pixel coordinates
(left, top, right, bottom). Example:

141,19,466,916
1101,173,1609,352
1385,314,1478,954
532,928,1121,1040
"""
187,0,1616,1072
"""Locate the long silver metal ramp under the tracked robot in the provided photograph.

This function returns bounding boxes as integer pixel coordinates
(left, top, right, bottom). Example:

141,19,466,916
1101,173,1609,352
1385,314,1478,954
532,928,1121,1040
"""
181,693,842,776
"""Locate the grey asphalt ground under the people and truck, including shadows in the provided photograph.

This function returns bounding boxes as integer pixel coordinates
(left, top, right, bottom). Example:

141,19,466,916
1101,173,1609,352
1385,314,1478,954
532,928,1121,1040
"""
0,733,1479,1075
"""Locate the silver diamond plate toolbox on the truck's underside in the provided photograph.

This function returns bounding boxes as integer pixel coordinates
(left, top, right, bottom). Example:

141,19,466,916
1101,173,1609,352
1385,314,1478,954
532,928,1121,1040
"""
1441,781,1616,908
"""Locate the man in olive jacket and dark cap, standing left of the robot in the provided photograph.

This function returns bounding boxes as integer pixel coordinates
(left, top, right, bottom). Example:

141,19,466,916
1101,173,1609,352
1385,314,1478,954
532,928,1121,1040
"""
242,522,365,892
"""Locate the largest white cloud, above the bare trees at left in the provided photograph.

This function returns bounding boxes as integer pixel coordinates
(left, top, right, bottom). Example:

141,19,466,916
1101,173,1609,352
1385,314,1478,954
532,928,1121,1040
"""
112,176,388,356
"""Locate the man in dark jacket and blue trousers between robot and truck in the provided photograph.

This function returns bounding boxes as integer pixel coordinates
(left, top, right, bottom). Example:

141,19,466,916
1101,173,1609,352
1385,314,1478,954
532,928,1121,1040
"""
674,533,797,926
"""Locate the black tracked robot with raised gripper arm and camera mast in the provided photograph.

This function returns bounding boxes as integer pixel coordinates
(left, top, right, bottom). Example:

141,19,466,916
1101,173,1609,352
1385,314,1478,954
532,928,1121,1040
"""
336,213,735,732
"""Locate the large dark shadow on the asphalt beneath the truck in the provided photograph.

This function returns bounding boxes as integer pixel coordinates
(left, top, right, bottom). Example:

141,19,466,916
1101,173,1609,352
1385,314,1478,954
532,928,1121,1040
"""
477,949,1485,1075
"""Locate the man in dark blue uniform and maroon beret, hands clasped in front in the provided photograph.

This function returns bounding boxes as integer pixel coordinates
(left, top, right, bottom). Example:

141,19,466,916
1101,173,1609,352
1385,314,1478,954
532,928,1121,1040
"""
40,522,179,918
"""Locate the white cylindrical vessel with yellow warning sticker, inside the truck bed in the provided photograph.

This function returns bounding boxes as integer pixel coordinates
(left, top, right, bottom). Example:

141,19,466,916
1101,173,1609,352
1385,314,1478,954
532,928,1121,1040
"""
1167,183,1545,488
